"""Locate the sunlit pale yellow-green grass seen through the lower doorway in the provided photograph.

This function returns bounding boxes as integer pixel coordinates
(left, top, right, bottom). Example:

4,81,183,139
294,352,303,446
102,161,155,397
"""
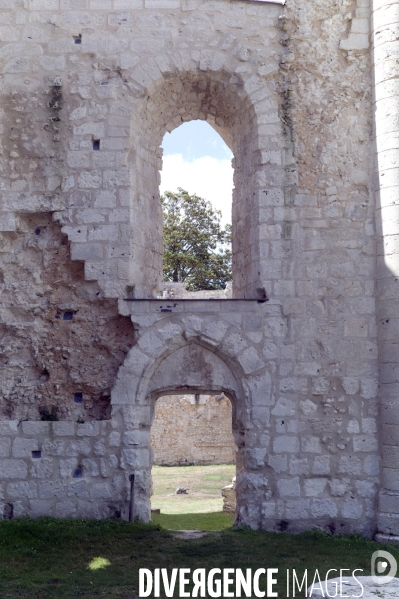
151,465,236,516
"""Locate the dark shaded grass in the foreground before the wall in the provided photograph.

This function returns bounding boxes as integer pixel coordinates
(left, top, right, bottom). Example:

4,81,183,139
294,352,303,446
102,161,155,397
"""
0,518,399,599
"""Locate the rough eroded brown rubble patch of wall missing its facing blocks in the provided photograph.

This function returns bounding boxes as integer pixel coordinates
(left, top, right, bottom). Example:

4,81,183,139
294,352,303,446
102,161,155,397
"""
0,213,134,422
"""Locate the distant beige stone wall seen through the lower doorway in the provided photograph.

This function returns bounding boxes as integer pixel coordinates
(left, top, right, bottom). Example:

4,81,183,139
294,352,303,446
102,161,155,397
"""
151,395,236,465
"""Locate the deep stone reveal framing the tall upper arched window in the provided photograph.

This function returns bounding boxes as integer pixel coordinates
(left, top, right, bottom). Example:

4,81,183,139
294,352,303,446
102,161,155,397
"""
130,71,268,298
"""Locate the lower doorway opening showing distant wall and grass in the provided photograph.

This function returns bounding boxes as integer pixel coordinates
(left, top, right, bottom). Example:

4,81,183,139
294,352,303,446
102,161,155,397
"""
151,393,237,530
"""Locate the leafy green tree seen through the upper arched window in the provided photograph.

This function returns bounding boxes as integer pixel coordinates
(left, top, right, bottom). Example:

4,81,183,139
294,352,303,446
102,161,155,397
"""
161,187,232,291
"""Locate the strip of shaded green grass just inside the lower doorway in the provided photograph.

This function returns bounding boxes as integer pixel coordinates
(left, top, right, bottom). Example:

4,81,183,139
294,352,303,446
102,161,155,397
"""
151,512,234,530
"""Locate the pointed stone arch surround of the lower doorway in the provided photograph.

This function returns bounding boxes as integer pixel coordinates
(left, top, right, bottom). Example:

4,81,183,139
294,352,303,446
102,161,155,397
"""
113,335,247,522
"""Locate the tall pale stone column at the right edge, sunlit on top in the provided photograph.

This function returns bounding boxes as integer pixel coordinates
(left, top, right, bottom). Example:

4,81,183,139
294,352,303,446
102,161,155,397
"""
372,0,399,540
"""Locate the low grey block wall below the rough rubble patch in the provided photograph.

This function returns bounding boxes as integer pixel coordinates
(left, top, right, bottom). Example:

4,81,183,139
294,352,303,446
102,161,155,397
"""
0,420,129,518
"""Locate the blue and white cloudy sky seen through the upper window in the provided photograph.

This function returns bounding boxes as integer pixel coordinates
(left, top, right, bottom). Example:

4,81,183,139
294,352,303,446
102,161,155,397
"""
161,121,233,224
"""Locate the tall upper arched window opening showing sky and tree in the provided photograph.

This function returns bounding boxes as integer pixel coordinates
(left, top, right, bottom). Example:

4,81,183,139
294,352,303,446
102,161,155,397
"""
160,120,234,299
